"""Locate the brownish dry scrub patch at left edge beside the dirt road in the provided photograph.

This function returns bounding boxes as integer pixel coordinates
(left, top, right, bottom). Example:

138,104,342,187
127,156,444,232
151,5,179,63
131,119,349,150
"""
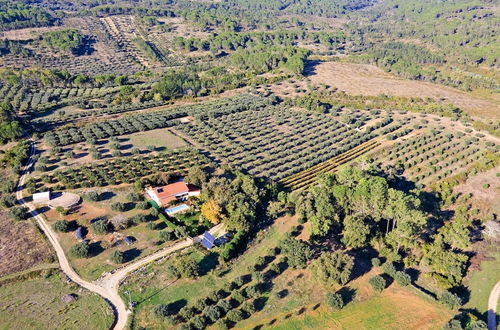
0,212,52,276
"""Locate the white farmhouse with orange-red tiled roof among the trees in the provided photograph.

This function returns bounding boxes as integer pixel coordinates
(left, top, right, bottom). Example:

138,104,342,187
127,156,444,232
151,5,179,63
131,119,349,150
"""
146,182,201,207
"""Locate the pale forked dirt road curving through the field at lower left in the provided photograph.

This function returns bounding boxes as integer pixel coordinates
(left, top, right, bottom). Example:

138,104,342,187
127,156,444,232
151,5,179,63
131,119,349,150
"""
16,143,223,330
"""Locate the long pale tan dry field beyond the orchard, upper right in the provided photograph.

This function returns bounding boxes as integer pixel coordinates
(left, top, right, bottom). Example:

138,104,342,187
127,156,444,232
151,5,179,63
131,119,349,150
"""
308,62,500,119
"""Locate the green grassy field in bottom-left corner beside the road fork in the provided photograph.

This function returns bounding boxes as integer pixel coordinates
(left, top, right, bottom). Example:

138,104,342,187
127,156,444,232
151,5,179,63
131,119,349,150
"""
0,273,113,330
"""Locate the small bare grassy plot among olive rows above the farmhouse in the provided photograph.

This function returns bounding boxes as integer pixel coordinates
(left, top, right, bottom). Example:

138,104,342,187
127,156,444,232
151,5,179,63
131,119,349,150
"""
126,129,186,149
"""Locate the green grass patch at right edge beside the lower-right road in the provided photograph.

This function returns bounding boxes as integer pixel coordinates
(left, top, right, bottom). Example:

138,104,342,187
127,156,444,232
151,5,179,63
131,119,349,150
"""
466,251,500,314
